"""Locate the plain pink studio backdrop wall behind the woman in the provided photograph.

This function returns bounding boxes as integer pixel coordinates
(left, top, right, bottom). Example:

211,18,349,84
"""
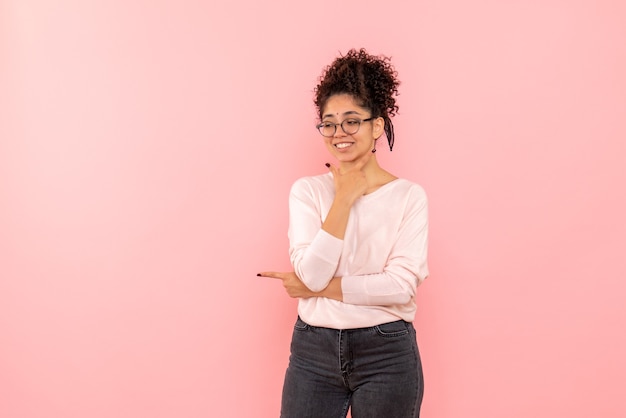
0,0,626,418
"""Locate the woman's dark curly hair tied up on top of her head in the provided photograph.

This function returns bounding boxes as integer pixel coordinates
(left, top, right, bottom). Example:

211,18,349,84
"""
314,48,400,150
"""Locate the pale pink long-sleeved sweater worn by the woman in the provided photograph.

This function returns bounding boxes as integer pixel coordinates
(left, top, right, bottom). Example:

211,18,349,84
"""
288,173,428,329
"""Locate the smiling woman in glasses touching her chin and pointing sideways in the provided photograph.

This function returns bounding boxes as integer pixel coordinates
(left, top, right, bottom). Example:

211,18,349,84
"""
259,49,428,418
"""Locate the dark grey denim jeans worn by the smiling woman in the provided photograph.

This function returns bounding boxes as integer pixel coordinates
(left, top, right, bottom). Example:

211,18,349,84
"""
280,318,424,418
